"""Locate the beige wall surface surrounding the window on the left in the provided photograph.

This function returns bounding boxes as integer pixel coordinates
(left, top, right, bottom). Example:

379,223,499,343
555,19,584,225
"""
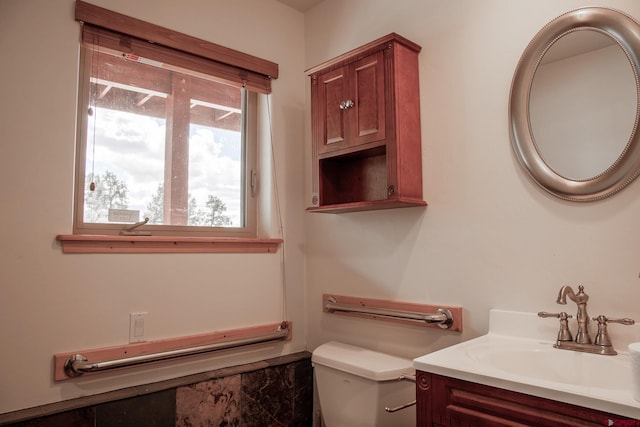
0,0,305,413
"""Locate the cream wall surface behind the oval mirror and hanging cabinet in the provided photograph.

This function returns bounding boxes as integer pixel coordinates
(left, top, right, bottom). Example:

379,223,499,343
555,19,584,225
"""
305,0,640,357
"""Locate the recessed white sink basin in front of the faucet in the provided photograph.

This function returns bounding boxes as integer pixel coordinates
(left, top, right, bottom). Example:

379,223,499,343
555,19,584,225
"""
465,340,631,390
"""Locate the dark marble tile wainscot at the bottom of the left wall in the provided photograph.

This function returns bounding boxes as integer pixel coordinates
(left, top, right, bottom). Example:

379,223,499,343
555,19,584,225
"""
0,352,313,427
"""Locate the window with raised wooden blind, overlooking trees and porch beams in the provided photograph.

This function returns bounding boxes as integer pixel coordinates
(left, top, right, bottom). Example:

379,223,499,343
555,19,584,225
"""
74,1,277,241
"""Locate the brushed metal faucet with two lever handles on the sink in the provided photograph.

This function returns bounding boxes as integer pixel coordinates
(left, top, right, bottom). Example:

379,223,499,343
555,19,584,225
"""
538,286,635,355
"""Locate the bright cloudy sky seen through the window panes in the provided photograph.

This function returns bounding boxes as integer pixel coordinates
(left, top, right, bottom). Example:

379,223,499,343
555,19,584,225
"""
85,108,242,227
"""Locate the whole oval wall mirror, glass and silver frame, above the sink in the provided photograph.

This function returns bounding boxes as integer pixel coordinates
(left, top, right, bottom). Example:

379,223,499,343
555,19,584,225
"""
509,7,640,201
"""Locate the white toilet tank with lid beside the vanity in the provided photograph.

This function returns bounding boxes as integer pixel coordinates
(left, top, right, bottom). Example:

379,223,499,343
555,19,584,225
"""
311,341,416,427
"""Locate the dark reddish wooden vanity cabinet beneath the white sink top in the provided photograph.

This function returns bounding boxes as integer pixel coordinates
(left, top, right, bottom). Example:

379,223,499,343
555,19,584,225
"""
416,371,635,427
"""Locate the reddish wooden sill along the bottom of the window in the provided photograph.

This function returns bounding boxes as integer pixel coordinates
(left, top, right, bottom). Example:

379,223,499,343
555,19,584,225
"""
56,234,283,254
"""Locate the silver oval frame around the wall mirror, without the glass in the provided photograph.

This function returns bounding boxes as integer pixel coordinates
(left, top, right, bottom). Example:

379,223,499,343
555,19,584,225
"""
509,7,640,202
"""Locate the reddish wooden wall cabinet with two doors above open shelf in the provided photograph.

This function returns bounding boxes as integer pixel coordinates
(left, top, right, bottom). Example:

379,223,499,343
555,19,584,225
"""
307,33,426,213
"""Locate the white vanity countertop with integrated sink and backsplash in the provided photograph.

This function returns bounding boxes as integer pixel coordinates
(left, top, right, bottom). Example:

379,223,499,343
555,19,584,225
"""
413,310,640,419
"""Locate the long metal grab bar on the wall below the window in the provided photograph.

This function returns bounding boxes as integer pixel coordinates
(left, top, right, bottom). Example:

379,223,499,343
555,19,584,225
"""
64,322,289,377
